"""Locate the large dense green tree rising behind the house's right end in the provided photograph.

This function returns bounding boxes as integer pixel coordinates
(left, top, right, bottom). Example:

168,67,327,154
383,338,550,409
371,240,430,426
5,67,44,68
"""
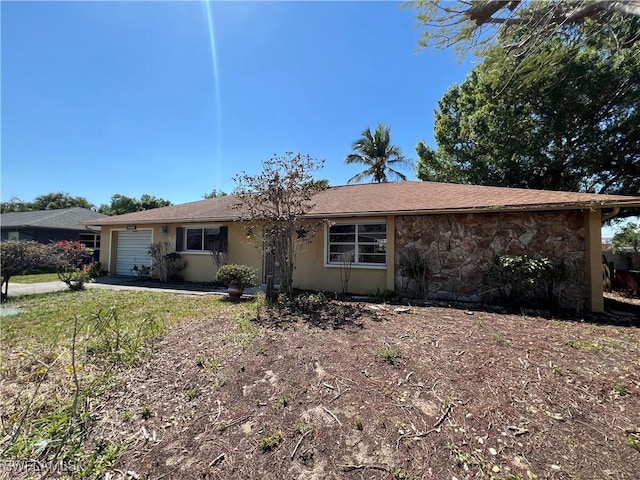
416,17,640,194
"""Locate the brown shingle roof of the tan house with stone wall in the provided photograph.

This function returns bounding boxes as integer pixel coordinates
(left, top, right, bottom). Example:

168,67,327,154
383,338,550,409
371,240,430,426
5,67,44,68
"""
85,182,640,225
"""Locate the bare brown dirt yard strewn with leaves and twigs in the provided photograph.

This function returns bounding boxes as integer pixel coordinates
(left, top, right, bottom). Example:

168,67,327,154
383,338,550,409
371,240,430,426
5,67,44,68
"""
94,302,640,480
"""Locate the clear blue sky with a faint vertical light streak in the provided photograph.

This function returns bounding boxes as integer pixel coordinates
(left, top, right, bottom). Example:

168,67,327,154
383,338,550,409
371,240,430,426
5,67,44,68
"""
1,1,473,206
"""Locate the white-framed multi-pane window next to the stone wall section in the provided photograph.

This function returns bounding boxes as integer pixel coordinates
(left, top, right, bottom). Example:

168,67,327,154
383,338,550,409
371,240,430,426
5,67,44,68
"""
327,223,387,266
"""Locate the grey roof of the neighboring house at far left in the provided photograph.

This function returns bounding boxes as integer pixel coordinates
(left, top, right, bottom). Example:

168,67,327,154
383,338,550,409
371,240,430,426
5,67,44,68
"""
0,207,106,230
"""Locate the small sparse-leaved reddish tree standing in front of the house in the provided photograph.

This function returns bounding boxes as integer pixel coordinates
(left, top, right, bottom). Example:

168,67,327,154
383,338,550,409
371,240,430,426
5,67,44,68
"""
234,152,328,296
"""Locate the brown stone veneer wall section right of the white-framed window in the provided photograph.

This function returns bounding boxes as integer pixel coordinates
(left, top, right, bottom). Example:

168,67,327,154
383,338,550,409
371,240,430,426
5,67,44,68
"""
395,210,587,310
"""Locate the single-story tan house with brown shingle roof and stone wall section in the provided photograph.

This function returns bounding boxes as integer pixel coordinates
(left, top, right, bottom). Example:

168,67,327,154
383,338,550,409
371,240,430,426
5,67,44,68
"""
85,182,640,311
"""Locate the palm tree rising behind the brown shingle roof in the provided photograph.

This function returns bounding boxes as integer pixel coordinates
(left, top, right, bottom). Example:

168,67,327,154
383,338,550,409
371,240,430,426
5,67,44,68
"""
344,123,411,183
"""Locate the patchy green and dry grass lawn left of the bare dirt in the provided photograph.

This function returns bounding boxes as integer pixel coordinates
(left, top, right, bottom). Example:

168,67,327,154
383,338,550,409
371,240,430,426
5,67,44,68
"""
0,290,255,478
